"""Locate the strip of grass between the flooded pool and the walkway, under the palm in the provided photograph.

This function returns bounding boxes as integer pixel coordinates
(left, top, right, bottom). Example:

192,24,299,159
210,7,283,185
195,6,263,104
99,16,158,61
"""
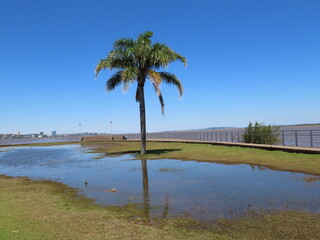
82,142,320,175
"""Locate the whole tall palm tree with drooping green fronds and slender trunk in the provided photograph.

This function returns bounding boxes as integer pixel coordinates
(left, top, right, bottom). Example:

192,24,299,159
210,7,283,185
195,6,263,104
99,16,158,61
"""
95,31,187,154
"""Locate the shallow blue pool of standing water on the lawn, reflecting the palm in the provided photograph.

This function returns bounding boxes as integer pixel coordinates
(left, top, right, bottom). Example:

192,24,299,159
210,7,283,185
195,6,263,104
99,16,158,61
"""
0,145,320,220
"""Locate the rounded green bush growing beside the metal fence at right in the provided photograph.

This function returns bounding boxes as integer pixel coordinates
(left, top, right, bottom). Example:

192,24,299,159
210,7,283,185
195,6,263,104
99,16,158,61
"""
243,122,280,144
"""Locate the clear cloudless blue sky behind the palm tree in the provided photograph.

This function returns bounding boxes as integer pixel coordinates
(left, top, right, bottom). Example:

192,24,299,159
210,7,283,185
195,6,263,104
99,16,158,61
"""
0,0,320,133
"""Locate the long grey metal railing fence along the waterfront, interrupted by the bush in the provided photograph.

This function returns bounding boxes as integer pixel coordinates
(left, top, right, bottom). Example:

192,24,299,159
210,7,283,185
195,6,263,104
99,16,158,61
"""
125,130,320,147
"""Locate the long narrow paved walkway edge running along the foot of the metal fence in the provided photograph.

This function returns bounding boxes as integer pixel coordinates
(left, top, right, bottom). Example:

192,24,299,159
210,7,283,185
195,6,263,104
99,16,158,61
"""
128,138,320,154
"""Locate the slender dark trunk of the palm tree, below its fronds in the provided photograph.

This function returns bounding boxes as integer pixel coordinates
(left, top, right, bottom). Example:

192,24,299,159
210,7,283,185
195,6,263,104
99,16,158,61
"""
138,85,147,154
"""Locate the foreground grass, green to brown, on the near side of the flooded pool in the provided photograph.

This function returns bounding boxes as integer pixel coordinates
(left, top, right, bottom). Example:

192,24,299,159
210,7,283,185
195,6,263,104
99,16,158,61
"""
0,176,320,240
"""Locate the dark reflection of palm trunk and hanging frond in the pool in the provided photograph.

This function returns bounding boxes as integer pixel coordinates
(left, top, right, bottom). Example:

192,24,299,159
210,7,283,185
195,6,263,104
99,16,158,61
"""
141,160,169,224
